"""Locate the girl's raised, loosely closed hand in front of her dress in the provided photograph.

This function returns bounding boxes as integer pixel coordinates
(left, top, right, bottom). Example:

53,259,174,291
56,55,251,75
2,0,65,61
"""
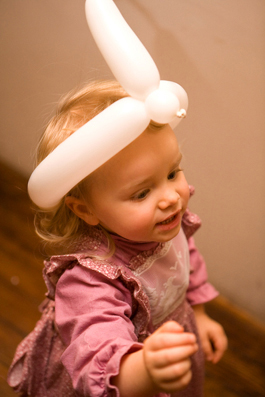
143,321,198,393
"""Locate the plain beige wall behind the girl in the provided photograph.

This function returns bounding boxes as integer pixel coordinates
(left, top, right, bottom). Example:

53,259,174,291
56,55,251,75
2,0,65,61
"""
0,0,265,321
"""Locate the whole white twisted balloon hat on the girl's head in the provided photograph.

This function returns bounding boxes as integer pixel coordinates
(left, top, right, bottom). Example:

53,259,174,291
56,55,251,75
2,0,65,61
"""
28,0,188,209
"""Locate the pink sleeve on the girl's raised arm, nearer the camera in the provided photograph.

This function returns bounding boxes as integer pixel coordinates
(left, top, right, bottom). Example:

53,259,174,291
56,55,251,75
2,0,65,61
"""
55,265,142,397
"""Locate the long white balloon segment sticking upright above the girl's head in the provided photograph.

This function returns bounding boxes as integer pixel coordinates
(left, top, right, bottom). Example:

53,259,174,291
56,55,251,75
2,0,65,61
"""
86,0,160,100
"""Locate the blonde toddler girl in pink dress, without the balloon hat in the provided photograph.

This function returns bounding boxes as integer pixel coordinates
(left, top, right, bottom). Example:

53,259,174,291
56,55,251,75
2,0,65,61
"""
8,81,227,397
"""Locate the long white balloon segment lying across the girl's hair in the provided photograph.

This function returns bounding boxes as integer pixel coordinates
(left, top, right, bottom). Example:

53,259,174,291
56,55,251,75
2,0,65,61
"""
28,97,150,208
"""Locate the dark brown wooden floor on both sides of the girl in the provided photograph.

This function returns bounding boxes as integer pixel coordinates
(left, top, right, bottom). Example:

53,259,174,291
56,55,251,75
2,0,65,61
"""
0,159,265,397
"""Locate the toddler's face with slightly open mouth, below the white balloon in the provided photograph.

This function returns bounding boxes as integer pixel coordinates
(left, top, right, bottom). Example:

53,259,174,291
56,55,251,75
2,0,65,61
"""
75,125,189,242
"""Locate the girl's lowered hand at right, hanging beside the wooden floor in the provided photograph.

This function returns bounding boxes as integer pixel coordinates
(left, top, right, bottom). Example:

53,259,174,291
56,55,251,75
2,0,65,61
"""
193,305,228,364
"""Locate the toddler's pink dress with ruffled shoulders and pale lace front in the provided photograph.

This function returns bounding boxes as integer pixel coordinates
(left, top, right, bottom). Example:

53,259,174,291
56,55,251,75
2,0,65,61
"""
8,201,217,397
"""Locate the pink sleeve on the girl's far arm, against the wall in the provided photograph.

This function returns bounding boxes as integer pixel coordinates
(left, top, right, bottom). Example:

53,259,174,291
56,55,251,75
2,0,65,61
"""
187,237,219,306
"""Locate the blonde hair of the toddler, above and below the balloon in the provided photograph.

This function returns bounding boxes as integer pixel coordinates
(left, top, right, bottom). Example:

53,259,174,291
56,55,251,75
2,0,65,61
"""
35,80,128,252
